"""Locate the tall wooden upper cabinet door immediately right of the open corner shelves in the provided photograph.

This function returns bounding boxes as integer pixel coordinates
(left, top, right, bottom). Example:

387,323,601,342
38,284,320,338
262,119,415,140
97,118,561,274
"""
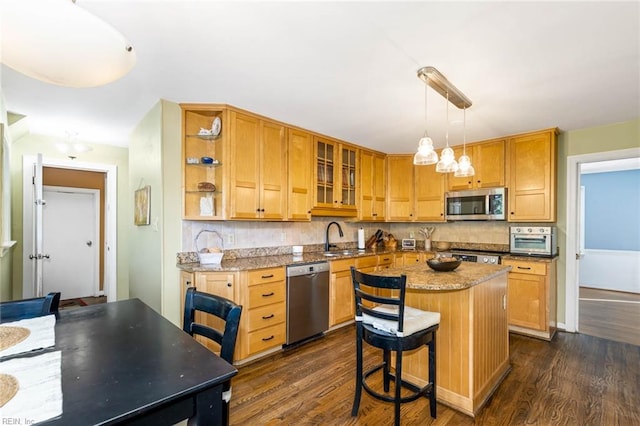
229,111,260,219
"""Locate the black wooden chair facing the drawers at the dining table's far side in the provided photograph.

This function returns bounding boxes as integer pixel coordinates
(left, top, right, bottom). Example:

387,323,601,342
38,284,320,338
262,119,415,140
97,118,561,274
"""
183,287,242,424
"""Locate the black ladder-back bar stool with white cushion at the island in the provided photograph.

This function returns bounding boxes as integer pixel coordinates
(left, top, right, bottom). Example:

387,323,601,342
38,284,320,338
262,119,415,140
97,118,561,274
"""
351,266,440,426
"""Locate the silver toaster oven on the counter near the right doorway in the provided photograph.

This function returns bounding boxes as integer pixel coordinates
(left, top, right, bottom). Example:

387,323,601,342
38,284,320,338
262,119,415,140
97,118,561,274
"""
509,226,558,257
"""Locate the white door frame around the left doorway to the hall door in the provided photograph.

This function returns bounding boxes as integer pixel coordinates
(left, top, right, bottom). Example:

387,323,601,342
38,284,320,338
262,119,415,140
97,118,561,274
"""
22,155,118,302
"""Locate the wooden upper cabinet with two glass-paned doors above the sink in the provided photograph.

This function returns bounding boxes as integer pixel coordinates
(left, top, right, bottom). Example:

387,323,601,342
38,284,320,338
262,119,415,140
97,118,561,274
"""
311,137,358,217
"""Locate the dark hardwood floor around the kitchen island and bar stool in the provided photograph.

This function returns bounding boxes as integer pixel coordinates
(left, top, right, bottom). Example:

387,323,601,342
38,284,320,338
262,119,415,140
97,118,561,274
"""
230,326,640,426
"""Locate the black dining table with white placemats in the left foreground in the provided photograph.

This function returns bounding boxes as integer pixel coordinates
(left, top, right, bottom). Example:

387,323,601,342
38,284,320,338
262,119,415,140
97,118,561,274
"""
35,299,238,426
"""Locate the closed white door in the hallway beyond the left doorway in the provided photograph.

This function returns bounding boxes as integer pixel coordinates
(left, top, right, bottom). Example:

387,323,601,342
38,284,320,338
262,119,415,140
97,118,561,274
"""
42,186,100,299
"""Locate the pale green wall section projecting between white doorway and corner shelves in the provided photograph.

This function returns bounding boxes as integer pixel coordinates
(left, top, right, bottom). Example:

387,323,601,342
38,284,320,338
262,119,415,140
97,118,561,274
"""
126,101,182,324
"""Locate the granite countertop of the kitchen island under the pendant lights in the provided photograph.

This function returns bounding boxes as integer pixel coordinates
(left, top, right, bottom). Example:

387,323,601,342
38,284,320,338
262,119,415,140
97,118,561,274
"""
374,262,511,290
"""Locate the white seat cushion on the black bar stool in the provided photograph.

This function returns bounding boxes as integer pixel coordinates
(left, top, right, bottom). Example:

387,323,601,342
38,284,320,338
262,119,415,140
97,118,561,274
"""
356,305,440,337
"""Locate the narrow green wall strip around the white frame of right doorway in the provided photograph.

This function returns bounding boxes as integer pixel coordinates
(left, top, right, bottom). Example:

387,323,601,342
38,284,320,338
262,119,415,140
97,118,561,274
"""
556,118,640,323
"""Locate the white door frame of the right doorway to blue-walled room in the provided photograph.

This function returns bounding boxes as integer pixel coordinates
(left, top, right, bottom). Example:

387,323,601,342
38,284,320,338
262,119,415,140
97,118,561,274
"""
565,148,640,333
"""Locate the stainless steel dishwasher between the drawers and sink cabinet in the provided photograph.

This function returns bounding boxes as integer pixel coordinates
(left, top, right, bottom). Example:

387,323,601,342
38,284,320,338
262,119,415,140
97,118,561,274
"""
286,262,329,345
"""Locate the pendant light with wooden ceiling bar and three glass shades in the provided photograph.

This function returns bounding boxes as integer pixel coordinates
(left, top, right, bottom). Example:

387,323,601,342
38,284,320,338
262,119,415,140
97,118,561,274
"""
413,67,474,176
